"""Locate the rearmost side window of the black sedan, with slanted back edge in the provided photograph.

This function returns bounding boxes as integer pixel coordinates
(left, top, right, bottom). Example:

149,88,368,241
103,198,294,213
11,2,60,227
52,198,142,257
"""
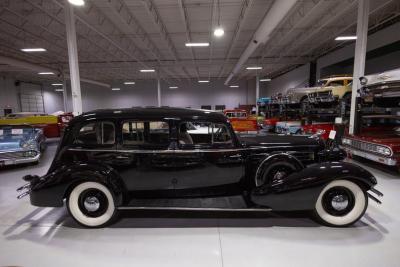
74,122,115,145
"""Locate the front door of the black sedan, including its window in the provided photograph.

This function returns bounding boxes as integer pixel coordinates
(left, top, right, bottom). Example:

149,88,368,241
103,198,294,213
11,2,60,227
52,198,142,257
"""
173,121,244,193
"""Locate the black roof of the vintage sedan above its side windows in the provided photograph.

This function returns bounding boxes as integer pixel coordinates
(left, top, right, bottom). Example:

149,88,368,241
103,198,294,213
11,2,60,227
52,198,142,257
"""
70,107,227,124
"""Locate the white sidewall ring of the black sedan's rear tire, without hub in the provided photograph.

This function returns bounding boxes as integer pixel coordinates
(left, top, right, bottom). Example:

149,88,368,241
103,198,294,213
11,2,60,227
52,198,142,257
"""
68,182,115,227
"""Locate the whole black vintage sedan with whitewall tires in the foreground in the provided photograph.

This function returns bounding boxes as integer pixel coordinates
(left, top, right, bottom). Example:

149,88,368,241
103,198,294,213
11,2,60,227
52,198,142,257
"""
19,107,381,227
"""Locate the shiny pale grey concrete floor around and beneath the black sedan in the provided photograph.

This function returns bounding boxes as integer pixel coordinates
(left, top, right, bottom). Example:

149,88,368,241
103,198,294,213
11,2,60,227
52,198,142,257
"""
0,141,400,267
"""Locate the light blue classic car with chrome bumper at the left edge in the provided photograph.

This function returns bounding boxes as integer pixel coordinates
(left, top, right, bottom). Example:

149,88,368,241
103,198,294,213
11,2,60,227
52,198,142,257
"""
0,125,45,167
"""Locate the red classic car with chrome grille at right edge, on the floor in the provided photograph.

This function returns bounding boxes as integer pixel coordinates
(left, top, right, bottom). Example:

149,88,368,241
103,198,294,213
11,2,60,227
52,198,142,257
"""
342,115,400,170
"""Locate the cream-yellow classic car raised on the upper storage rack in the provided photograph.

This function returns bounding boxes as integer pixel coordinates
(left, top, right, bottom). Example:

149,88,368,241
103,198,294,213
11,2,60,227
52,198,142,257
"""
308,76,353,104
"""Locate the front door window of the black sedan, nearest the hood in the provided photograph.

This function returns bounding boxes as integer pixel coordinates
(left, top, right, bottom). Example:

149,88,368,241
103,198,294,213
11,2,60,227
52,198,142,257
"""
178,122,233,148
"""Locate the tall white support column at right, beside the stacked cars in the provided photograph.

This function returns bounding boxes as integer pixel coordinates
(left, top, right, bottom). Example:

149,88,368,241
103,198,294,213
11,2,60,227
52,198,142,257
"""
349,0,369,134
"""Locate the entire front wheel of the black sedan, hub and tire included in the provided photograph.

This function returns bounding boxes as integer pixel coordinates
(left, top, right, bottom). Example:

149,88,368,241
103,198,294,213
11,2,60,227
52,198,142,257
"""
314,180,368,227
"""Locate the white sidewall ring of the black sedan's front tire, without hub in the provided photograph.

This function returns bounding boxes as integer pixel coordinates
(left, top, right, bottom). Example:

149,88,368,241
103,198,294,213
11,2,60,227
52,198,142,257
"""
315,180,367,226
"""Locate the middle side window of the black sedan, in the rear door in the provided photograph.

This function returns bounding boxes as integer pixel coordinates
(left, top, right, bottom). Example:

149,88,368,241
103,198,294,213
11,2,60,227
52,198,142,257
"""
122,121,169,145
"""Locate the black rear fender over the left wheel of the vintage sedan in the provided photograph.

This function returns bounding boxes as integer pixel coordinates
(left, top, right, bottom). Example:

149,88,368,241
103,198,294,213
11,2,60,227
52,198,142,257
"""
30,162,127,207
